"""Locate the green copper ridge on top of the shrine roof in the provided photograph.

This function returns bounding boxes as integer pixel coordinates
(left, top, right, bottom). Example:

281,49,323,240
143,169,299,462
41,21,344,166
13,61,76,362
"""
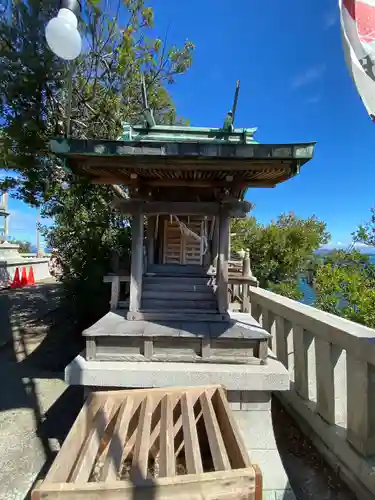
118,122,258,144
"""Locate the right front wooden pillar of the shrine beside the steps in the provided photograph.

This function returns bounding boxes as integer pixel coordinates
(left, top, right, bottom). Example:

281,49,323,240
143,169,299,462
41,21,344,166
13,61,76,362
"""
216,211,229,314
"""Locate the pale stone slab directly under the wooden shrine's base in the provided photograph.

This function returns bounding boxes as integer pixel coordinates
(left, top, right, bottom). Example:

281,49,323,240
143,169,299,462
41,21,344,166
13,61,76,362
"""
65,355,289,392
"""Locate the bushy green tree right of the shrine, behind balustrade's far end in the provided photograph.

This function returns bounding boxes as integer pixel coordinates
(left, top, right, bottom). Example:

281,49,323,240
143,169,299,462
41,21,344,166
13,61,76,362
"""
231,213,329,298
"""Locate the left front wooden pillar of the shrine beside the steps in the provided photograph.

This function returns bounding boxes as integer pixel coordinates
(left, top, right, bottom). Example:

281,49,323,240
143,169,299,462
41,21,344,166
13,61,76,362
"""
129,212,143,313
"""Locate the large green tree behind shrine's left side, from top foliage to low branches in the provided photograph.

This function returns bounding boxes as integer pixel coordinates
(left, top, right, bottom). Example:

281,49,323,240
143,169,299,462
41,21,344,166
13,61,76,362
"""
0,0,194,321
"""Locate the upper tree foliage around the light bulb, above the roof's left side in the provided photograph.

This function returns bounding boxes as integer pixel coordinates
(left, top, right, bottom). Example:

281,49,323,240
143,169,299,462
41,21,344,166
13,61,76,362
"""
0,0,194,204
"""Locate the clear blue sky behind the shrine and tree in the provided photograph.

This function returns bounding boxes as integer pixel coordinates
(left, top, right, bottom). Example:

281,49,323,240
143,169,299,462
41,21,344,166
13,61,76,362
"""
3,0,375,244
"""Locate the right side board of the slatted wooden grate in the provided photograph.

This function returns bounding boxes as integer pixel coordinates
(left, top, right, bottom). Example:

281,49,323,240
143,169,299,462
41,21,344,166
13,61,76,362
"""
213,387,251,468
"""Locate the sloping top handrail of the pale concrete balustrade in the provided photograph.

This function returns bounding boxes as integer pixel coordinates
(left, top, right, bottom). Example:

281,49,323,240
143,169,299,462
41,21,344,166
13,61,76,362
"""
250,287,375,365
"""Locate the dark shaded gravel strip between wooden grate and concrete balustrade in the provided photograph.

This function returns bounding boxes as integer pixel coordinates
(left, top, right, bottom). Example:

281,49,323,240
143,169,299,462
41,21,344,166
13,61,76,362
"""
272,397,357,500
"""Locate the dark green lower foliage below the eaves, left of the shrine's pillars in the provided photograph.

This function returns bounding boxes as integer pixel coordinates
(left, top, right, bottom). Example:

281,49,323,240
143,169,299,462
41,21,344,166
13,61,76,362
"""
43,182,131,325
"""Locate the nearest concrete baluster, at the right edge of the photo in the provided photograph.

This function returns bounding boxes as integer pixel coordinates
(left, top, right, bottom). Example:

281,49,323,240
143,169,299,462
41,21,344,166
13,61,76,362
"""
346,352,375,457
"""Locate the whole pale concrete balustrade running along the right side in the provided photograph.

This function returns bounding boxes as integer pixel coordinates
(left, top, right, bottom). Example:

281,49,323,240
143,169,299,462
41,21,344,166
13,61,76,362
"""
250,287,375,499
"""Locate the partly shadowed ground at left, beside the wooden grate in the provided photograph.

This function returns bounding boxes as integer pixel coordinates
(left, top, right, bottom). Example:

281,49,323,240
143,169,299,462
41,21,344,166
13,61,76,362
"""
0,283,88,500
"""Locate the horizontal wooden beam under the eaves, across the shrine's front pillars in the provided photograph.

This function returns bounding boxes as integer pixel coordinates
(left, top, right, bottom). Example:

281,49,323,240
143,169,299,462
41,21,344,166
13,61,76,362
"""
113,200,252,217
